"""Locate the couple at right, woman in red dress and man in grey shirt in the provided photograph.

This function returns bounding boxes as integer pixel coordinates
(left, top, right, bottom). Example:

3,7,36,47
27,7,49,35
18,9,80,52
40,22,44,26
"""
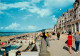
67,32,80,54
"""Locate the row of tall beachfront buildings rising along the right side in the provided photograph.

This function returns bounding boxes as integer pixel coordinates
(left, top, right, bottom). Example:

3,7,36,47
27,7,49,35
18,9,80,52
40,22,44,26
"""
54,0,80,33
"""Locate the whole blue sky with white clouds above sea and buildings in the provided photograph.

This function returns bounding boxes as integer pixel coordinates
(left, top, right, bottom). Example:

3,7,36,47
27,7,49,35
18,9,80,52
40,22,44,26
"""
0,0,75,32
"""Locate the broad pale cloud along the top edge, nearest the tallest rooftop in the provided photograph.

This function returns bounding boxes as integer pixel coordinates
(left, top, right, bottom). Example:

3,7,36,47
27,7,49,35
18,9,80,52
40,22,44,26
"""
44,0,75,8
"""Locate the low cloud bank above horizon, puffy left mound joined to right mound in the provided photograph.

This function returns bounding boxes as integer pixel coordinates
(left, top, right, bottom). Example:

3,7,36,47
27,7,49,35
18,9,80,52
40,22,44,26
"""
4,23,38,31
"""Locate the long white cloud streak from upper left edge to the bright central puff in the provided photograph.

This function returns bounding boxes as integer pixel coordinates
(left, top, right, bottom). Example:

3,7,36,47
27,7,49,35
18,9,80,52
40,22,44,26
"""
0,0,50,17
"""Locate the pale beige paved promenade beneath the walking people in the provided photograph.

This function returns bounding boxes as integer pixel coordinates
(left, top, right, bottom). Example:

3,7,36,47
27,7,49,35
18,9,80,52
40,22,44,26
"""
48,35,80,56
